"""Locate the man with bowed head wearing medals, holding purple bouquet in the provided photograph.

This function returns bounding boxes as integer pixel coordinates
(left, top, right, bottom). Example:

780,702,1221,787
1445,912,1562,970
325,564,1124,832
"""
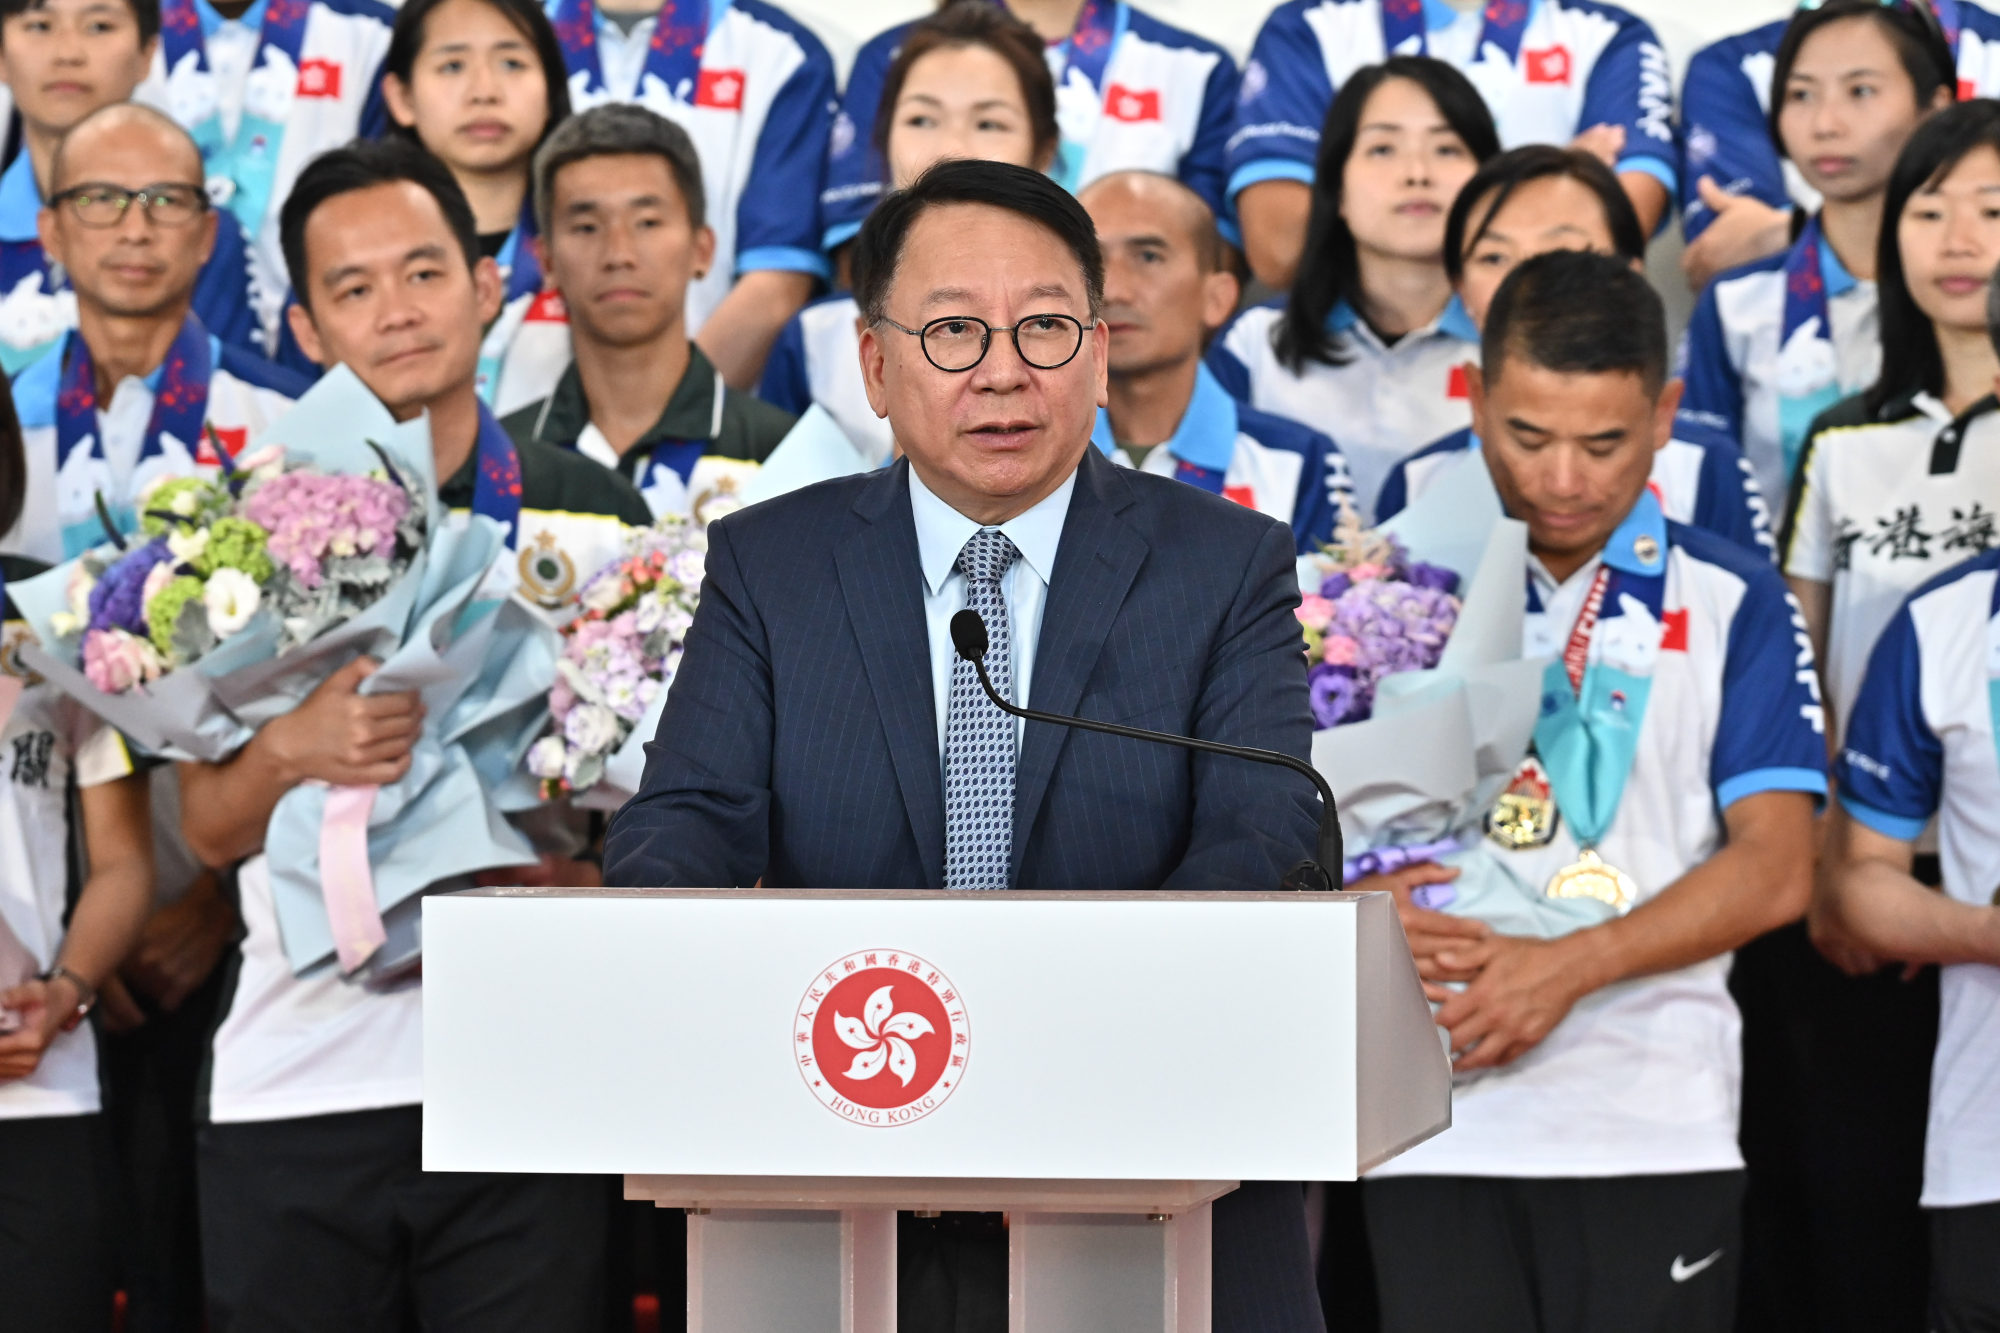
1354,250,1826,1333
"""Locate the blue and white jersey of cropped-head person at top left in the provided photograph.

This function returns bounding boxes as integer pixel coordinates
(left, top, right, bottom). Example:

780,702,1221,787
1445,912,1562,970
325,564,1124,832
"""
132,0,396,350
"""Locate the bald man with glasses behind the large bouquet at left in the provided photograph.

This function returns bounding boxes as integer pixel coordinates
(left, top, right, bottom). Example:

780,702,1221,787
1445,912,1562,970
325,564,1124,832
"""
0,102,302,560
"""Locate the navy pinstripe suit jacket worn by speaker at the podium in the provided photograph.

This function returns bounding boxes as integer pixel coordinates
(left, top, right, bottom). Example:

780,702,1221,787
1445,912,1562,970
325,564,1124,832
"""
604,448,1318,889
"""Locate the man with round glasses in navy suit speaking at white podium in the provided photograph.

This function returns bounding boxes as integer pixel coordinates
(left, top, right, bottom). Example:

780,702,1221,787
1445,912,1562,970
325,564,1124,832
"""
606,162,1324,1333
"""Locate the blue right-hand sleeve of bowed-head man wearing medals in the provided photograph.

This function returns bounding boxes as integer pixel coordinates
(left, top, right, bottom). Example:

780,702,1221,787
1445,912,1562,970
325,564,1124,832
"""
1708,566,1826,811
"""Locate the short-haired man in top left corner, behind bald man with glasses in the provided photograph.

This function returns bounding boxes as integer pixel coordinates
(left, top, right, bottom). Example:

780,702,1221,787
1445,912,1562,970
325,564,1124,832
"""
0,0,262,374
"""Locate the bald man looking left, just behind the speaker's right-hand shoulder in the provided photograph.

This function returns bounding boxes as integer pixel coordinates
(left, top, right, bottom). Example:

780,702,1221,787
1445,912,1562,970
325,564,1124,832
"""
1078,172,1352,554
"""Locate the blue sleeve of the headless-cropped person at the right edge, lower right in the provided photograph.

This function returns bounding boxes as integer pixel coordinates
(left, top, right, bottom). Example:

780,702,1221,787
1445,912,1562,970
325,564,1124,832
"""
1834,602,1944,843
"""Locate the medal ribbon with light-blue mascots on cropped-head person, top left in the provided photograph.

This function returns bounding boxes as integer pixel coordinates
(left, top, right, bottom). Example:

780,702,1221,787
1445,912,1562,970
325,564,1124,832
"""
160,0,312,236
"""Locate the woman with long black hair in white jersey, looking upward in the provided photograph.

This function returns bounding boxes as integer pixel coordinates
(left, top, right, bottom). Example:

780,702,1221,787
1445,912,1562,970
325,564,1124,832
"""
1208,56,1500,510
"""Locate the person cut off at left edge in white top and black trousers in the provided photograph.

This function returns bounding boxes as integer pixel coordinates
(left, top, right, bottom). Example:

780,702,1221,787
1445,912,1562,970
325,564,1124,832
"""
0,392,152,1329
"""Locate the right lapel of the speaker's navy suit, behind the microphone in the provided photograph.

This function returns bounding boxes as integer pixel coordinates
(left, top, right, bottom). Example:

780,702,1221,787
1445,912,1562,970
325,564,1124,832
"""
1014,448,1146,875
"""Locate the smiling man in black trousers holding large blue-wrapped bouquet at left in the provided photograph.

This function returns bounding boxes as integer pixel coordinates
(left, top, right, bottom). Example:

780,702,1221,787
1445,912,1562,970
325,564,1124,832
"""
182,142,648,1333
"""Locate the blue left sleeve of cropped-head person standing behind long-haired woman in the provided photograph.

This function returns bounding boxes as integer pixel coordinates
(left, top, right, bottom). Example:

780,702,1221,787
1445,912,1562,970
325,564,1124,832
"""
1226,4,1334,200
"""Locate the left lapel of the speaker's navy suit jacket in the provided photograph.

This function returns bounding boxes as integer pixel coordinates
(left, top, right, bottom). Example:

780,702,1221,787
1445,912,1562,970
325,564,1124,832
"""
830,462,944,887
